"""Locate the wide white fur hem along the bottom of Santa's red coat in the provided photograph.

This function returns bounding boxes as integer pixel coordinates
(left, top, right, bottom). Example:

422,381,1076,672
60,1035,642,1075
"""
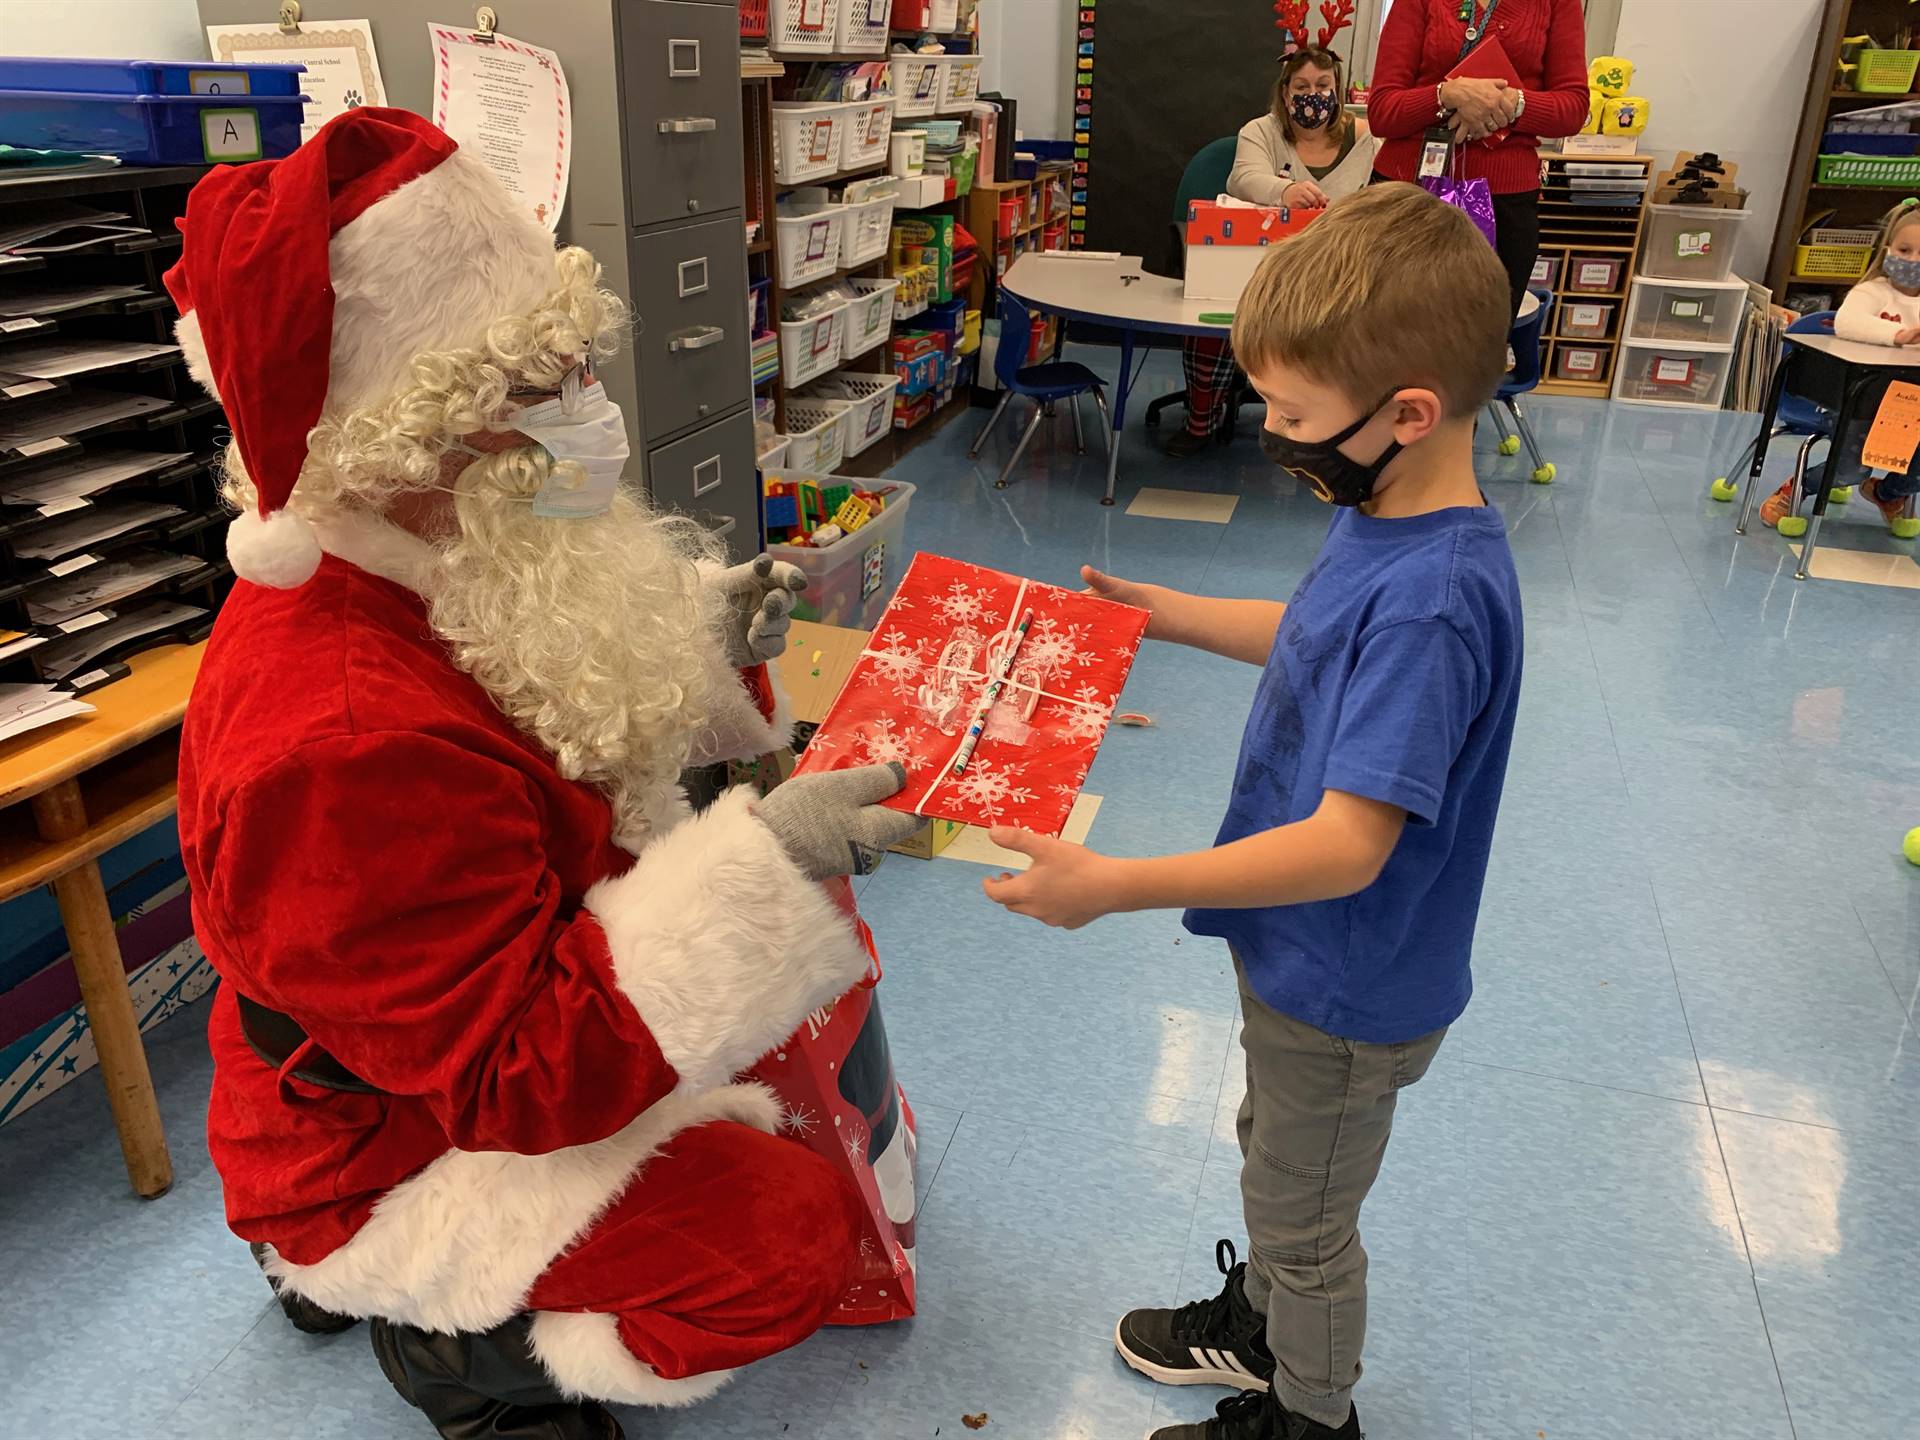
267,1085,780,1332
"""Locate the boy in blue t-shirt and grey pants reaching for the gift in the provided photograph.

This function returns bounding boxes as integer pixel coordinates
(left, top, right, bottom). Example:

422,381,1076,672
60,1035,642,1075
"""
987,184,1521,1440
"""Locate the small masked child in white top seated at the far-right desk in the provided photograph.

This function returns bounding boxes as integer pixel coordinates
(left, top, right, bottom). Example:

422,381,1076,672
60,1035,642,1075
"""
1761,200,1920,540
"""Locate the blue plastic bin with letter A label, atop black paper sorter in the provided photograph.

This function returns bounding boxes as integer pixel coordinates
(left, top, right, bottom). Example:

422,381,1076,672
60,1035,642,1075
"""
0,90,307,165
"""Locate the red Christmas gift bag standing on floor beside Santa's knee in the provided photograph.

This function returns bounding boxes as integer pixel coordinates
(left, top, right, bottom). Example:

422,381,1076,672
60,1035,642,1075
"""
747,879,914,1325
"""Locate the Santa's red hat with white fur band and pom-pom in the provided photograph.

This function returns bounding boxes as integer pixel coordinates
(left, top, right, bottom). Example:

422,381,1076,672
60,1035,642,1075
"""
167,108,557,589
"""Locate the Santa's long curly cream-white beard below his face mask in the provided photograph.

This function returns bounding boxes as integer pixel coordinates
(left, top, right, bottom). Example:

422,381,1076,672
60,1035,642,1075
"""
428,449,718,851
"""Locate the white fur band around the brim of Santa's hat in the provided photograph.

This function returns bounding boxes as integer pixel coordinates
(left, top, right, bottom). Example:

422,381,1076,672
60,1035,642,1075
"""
326,150,559,415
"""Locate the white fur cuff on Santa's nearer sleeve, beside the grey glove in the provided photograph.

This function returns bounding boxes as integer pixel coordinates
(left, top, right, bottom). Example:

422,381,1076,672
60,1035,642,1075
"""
588,789,868,1092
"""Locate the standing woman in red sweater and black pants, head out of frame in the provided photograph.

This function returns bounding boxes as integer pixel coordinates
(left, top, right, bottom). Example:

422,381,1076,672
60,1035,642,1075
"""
1367,0,1588,315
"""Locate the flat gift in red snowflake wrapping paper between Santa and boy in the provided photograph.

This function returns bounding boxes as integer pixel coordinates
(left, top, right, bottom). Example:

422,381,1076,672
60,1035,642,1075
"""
797,553,1148,835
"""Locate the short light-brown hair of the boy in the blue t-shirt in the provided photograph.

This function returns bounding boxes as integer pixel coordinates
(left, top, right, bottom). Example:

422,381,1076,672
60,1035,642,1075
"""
1233,182,1513,419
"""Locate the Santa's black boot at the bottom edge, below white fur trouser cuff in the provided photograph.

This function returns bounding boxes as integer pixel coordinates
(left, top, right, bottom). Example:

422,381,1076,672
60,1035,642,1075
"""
367,1315,624,1440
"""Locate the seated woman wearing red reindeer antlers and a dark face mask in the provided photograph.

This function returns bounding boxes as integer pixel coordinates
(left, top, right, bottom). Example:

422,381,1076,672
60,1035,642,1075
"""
1167,0,1379,459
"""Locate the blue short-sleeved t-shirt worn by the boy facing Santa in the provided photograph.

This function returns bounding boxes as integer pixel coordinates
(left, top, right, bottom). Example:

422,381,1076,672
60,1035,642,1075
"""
1187,505,1521,1044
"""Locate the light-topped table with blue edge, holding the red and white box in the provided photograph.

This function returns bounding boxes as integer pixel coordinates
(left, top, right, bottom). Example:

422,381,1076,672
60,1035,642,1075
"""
1000,252,1233,505
